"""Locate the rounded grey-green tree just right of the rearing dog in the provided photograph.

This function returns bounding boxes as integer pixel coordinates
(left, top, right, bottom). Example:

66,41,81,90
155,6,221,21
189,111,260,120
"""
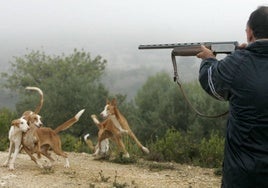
135,72,189,139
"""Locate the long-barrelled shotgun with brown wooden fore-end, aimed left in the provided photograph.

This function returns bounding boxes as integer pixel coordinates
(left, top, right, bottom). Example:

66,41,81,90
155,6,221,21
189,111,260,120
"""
139,41,238,56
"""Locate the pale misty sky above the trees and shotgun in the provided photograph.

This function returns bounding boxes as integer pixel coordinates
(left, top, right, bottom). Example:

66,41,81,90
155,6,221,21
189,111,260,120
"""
0,0,267,71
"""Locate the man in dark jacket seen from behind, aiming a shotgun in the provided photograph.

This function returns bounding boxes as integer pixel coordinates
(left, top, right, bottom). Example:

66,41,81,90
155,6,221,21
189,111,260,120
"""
197,6,268,188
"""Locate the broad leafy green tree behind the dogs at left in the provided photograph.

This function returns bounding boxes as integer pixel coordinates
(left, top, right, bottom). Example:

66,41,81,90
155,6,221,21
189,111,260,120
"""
2,49,108,135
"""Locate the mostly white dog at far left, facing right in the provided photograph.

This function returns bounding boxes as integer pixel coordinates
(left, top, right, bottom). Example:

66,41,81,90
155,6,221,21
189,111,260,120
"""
3,117,30,170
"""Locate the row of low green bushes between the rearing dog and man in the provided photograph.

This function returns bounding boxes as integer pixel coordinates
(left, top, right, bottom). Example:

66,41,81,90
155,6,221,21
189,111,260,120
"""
147,129,224,168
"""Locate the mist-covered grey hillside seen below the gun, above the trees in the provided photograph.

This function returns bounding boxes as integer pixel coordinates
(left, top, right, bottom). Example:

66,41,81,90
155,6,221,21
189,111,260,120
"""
102,57,199,100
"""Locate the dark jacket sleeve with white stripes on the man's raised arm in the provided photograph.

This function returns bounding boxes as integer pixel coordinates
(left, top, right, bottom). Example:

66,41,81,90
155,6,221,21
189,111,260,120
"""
199,54,239,100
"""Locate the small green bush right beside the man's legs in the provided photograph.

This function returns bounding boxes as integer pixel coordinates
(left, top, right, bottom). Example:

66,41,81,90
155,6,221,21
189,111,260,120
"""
199,132,224,167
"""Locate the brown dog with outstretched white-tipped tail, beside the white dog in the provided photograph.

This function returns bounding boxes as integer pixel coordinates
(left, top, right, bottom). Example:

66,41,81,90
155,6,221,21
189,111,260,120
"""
22,109,85,168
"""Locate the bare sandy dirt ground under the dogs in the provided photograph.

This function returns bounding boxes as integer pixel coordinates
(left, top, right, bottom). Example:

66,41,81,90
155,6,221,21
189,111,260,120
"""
0,152,221,188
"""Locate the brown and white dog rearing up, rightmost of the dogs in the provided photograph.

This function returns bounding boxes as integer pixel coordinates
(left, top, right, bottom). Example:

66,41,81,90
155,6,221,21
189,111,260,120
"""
91,99,150,158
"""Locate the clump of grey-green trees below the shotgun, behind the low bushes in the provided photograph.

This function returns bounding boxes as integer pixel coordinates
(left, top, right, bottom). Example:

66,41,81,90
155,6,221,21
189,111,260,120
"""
135,72,227,140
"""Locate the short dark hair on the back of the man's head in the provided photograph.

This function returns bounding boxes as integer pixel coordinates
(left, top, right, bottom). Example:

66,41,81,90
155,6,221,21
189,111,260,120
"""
247,6,268,39
